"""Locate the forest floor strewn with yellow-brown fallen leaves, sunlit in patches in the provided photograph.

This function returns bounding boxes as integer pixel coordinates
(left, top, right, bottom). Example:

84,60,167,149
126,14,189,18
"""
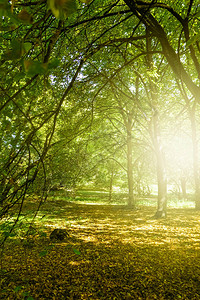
0,199,200,300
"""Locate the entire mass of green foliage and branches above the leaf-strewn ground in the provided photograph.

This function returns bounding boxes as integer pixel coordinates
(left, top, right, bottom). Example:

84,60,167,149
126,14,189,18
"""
0,0,200,221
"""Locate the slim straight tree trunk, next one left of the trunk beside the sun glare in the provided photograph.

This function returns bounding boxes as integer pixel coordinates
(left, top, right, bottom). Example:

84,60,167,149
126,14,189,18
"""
126,119,135,207
